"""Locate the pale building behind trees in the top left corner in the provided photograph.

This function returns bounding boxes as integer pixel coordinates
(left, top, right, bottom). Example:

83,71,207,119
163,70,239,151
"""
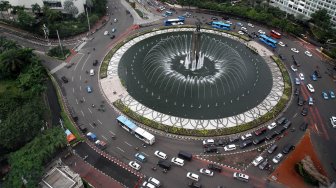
0,0,86,15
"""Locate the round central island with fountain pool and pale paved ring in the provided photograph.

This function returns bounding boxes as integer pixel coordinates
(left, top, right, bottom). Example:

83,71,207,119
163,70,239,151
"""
100,28,284,130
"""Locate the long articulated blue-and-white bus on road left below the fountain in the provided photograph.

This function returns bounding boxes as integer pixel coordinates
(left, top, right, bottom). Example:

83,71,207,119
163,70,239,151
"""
117,116,155,145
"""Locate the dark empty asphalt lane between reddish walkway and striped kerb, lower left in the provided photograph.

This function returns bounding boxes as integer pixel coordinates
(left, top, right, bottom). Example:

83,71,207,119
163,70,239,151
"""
74,143,139,187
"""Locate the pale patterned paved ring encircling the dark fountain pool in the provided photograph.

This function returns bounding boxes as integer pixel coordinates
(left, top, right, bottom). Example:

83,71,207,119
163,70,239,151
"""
100,28,284,129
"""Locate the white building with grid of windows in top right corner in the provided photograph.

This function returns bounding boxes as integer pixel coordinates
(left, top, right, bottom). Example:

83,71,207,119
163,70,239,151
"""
270,0,336,25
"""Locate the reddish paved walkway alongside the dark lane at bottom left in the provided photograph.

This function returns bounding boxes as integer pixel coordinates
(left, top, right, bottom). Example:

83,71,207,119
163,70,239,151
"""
64,155,123,188
